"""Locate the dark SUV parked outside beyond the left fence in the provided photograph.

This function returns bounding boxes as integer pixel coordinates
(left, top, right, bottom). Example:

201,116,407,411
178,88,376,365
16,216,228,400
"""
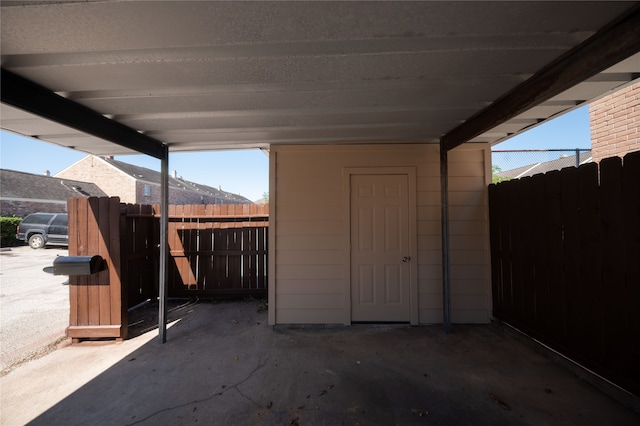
16,213,69,249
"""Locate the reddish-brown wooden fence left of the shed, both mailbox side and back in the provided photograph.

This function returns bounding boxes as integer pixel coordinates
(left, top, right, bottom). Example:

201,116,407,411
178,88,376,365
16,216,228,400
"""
67,197,269,340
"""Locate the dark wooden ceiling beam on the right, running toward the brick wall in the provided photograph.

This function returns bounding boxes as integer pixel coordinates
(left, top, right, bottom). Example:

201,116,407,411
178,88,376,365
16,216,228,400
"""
440,6,640,151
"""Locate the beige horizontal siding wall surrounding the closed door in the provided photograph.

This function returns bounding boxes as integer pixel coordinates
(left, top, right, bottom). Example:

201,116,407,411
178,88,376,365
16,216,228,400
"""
270,145,491,324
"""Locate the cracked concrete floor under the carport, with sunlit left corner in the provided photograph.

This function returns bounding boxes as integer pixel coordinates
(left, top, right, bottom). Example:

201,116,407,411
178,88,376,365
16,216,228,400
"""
0,301,640,425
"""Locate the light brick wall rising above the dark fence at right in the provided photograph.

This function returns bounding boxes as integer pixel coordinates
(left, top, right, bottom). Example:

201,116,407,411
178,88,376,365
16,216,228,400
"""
589,83,640,162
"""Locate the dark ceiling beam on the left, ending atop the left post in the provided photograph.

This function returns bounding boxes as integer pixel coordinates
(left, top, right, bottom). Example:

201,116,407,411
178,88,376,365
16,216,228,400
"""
1,68,167,160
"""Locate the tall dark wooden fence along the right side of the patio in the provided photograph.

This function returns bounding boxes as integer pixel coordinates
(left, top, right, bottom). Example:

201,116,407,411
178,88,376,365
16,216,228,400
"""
489,152,640,395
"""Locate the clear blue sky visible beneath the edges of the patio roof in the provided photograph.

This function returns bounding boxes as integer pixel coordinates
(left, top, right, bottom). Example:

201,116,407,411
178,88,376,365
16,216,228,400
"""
0,106,591,201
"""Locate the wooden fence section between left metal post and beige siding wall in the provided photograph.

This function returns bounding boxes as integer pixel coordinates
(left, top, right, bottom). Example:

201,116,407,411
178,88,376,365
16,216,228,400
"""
162,204,269,297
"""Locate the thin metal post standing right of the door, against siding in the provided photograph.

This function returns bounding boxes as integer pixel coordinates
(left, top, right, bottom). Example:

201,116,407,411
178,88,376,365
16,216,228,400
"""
440,143,451,334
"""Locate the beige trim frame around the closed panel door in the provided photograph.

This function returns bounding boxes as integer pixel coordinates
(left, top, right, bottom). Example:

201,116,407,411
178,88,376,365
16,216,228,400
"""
342,167,418,325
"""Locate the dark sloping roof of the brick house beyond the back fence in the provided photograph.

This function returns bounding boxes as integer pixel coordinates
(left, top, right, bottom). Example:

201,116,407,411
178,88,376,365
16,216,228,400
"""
100,157,252,204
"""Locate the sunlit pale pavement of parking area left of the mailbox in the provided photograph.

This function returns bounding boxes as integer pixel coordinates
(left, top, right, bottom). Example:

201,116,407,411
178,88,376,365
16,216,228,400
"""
0,246,69,374
